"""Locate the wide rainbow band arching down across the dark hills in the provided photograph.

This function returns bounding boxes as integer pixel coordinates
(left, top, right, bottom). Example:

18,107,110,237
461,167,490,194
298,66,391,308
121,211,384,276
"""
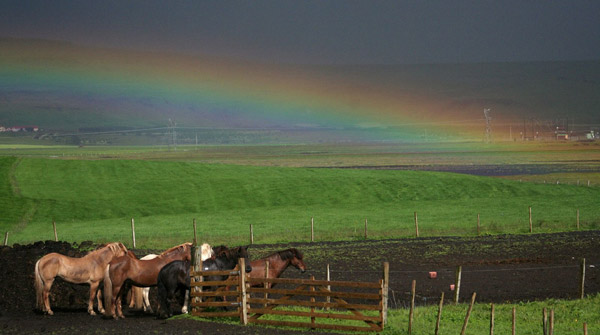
0,40,478,140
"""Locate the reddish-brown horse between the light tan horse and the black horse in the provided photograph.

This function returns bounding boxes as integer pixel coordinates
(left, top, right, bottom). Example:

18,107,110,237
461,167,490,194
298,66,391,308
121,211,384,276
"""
104,243,192,319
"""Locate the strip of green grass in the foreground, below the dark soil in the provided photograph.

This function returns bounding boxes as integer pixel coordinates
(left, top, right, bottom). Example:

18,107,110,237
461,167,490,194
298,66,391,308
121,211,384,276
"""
175,294,600,335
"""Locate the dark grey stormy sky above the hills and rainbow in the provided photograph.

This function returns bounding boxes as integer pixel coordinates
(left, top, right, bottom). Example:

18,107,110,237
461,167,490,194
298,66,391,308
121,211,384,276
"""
0,0,600,64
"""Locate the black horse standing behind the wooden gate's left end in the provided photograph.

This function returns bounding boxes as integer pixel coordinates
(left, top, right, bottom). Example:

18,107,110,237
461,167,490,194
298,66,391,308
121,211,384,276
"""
156,246,252,318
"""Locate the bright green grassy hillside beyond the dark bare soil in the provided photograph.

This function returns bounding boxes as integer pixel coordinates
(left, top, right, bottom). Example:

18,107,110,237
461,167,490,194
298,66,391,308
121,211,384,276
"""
0,157,600,247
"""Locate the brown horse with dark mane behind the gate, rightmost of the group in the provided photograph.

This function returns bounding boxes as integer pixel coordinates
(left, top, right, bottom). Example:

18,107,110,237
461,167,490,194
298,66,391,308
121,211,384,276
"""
249,248,306,287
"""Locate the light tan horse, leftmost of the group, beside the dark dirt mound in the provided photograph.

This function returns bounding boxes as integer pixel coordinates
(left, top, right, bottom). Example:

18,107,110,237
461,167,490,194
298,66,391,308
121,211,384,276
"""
35,242,127,315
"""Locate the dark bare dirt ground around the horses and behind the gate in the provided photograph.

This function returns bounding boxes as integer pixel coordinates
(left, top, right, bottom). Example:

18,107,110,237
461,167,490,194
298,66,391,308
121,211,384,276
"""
0,231,600,335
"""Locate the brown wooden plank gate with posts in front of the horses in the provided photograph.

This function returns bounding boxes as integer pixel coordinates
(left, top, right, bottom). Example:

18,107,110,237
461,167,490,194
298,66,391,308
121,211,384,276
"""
190,259,389,332
